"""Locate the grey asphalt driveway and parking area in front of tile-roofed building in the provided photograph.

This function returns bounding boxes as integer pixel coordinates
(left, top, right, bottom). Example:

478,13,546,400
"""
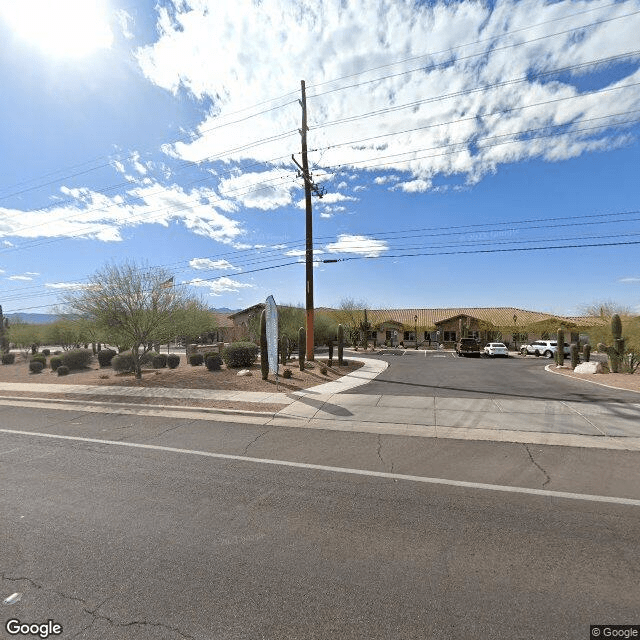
345,350,640,403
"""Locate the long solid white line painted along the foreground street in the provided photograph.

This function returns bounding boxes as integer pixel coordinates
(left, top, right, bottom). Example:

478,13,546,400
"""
0,429,640,507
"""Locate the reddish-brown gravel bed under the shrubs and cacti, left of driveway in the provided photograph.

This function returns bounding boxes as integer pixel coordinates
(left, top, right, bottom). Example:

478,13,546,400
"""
0,355,362,393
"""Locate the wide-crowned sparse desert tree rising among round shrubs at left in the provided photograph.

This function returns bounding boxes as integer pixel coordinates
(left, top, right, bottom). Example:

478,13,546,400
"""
64,261,215,378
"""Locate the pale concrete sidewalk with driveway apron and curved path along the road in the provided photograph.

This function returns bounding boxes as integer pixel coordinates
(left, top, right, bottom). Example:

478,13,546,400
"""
0,358,640,451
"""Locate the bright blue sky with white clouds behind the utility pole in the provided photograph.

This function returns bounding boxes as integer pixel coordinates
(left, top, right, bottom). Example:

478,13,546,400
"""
0,0,640,315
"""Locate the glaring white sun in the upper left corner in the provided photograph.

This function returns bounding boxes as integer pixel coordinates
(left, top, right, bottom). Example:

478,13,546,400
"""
0,0,113,57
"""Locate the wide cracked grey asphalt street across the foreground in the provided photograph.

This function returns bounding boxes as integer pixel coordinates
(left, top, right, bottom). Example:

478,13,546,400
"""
0,407,640,640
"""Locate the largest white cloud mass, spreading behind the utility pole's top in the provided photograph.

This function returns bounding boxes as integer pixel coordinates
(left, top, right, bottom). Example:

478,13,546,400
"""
137,0,640,190
